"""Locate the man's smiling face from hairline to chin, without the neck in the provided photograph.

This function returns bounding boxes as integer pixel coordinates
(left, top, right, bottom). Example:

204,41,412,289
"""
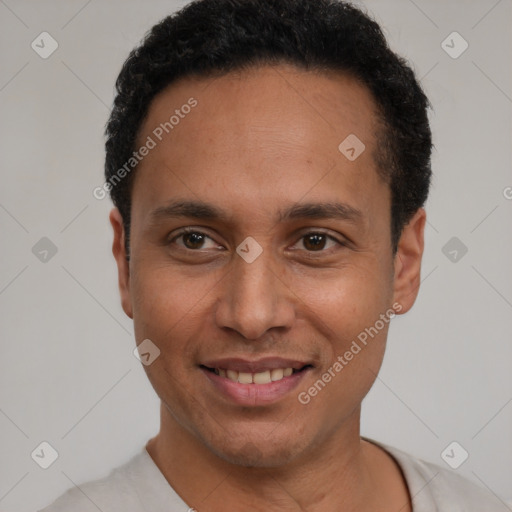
110,66,422,466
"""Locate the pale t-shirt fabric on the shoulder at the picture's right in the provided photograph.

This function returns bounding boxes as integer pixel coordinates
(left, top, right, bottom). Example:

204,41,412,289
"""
372,441,506,512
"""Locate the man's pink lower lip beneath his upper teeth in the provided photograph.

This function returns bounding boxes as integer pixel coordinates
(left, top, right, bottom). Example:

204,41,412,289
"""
201,368,312,406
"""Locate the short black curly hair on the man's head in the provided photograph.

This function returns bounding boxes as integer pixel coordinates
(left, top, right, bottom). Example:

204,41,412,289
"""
105,0,432,255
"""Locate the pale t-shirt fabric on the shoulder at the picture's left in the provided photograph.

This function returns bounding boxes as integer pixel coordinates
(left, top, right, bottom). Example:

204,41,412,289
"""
39,448,189,512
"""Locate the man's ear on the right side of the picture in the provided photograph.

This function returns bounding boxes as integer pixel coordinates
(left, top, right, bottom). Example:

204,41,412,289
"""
393,208,427,314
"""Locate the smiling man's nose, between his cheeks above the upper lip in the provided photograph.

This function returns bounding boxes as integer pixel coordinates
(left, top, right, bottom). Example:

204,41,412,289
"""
215,250,295,340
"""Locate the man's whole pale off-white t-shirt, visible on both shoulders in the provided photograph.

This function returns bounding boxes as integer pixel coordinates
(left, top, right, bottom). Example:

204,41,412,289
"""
39,440,510,512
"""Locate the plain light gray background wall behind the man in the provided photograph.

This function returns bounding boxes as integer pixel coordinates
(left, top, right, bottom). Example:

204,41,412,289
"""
0,0,512,512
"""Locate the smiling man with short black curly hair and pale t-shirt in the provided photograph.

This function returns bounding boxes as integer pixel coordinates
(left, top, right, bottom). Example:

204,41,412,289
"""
39,0,503,512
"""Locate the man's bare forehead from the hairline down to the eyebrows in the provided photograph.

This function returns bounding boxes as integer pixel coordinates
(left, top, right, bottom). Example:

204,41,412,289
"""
133,65,388,222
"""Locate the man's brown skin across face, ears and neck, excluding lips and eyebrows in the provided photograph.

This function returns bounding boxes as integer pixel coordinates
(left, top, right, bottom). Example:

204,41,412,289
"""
110,65,425,512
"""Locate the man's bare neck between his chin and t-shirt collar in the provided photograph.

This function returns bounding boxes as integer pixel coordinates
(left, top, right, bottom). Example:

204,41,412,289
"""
146,404,408,512
